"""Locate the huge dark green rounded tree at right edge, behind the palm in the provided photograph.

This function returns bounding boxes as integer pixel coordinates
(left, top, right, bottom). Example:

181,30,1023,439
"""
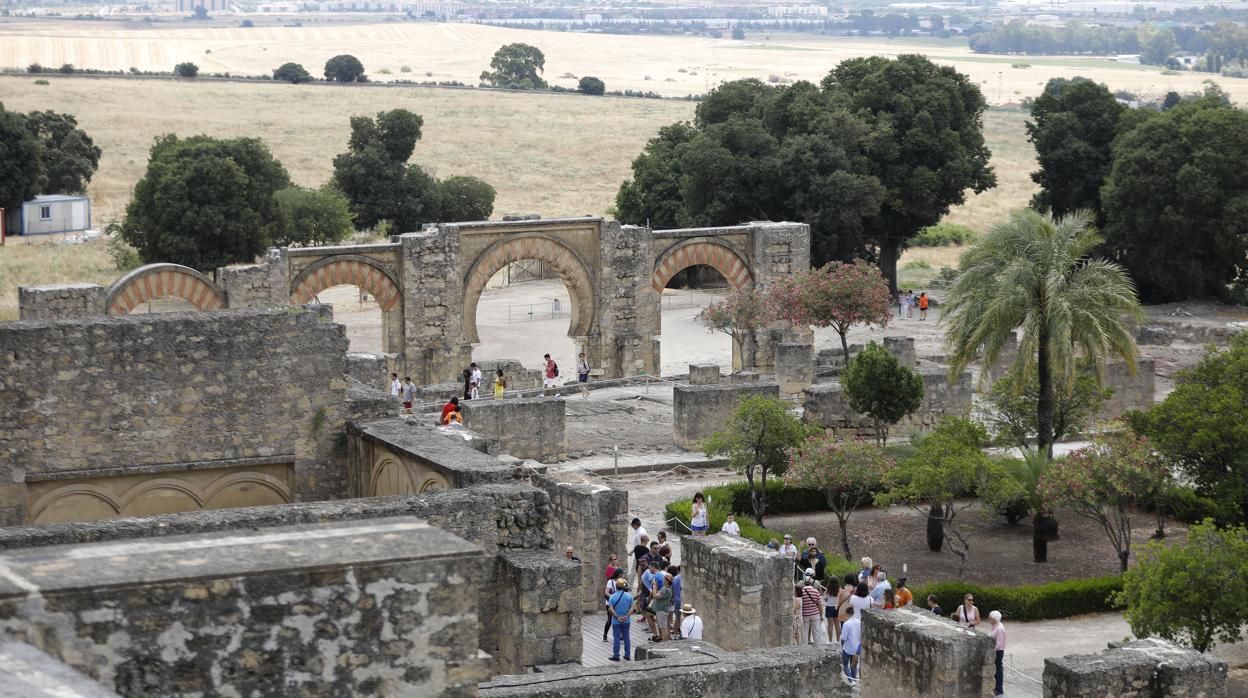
1101,94,1248,302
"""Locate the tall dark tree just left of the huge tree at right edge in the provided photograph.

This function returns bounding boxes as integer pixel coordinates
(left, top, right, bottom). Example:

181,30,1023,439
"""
1027,77,1127,224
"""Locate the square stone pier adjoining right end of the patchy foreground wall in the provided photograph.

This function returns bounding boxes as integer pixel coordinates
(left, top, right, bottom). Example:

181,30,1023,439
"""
493,551,583,673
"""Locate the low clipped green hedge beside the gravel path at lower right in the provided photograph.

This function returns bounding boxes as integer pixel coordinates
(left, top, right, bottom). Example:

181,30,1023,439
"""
910,574,1122,621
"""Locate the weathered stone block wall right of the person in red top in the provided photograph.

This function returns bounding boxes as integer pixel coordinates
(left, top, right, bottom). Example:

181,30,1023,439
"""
461,397,565,462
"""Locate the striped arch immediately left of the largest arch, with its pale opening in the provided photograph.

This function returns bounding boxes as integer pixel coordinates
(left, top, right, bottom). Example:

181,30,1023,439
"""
291,255,403,353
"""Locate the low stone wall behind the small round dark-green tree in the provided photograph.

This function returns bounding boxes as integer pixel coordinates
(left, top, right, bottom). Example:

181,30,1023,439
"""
801,363,975,438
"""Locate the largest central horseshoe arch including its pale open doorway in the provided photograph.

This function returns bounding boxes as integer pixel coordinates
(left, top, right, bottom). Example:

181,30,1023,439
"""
463,235,598,377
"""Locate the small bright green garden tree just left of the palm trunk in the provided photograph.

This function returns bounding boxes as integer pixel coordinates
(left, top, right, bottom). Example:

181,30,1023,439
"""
875,417,1005,579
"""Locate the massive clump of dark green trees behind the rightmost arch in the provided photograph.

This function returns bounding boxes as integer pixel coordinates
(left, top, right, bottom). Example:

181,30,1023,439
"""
617,56,996,292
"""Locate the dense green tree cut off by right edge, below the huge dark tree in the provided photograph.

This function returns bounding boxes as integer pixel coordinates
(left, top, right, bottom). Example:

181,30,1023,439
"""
1128,333,1248,524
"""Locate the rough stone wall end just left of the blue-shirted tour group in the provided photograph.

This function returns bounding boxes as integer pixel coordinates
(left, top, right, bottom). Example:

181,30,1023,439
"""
532,474,630,608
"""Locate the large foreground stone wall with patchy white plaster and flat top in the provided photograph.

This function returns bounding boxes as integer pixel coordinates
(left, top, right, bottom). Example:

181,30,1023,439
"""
0,518,488,697
